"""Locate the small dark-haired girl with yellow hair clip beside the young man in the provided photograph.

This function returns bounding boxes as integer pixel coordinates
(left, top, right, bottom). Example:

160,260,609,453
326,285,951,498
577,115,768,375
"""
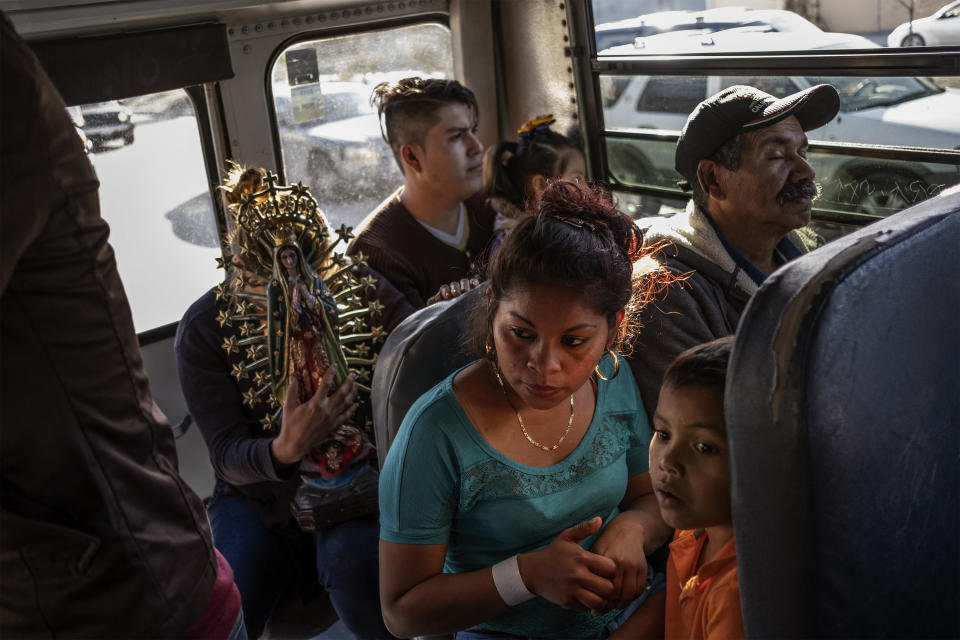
483,114,587,246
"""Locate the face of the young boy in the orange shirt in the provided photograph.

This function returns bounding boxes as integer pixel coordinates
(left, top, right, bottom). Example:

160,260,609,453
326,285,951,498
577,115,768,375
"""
650,385,732,529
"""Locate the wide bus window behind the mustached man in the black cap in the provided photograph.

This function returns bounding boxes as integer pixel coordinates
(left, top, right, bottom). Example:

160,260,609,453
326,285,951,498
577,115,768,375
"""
585,0,960,238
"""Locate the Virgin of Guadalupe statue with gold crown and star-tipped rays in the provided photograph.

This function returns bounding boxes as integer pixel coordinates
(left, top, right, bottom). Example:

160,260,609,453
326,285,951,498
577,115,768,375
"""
217,167,383,531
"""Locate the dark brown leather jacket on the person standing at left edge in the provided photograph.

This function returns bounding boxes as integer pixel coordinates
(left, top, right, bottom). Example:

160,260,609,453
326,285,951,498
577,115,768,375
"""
0,16,217,638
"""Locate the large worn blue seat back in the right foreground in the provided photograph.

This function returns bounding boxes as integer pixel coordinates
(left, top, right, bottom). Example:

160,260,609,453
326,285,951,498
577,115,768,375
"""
726,182,960,638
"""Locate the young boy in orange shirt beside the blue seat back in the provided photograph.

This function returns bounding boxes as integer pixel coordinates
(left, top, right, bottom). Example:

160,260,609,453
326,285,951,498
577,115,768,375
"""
613,336,743,640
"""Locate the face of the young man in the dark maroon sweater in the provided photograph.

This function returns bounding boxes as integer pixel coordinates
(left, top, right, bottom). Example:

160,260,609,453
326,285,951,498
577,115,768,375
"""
418,102,483,200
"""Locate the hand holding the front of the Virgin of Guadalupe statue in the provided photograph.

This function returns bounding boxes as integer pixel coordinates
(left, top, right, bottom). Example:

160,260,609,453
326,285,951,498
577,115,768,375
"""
270,364,357,465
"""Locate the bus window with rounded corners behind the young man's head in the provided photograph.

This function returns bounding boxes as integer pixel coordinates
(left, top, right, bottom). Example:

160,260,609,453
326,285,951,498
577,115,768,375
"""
272,23,453,228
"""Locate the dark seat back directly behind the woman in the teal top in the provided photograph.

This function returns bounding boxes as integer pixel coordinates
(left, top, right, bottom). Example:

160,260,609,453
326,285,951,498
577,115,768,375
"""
370,285,486,466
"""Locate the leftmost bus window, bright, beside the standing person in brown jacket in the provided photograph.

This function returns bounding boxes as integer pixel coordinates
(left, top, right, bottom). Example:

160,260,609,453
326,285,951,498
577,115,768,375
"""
80,89,221,333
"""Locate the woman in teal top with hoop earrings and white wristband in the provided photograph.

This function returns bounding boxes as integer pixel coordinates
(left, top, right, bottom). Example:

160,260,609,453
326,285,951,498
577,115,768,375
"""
380,181,671,640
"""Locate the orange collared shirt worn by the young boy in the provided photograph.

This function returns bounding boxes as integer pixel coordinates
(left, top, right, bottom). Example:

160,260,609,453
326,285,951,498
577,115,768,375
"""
665,531,744,640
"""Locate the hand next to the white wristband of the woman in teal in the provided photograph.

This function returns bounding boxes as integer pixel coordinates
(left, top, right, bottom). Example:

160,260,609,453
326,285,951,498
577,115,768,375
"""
517,518,617,611
